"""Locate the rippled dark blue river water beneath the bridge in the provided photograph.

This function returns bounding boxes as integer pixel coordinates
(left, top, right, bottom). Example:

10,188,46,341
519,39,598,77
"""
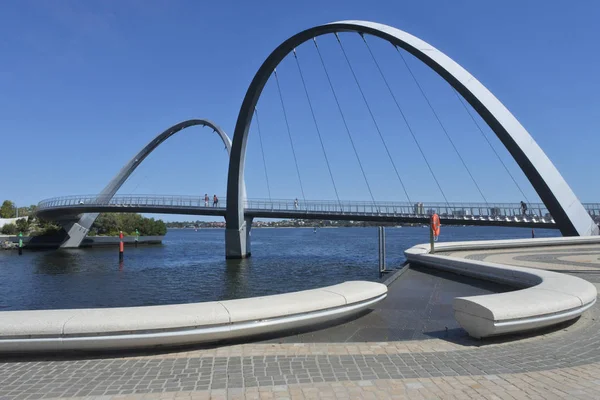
0,227,560,310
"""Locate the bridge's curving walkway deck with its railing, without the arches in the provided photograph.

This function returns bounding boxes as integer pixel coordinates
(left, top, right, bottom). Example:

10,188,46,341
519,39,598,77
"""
37,195,600,228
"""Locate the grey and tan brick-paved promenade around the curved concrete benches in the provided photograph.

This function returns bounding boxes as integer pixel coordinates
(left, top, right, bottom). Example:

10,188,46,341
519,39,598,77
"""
0,242,600,399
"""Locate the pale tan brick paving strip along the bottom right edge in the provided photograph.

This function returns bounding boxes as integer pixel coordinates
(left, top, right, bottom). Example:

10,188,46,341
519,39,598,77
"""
9,364,600,400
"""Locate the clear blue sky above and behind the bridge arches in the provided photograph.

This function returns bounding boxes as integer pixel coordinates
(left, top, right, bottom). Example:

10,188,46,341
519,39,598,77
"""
0,0,600,219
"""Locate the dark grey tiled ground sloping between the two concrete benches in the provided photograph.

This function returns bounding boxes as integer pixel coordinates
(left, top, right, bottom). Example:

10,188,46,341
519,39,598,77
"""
260,267,511,343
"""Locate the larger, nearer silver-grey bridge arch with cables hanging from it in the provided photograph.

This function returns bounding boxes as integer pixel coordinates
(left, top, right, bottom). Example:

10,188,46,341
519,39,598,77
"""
226,21,598,257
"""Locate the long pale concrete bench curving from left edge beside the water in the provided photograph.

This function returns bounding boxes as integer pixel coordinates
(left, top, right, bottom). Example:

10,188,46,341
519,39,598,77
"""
0,281,387,352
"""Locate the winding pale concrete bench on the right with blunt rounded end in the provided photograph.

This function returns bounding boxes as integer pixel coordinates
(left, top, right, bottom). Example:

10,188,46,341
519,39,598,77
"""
405,238,598,338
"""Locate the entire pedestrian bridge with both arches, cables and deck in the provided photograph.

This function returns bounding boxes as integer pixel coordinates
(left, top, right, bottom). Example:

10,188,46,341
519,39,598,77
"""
38,21,600,258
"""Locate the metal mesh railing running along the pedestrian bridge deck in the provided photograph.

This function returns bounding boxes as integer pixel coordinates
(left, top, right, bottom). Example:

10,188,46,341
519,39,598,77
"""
38,194,600,222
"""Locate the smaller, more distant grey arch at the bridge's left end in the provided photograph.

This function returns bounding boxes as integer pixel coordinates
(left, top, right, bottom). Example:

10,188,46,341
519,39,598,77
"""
61,119,239,248
